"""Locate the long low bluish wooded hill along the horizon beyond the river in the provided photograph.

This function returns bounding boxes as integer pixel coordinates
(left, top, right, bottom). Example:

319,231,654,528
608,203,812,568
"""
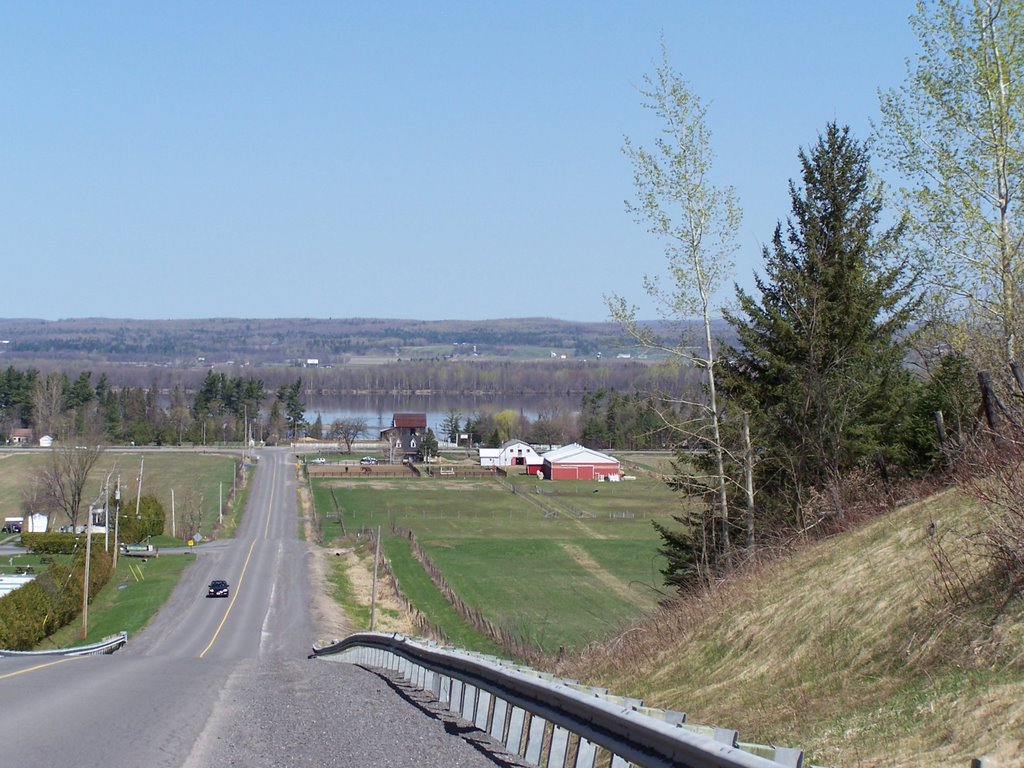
0,317,737,368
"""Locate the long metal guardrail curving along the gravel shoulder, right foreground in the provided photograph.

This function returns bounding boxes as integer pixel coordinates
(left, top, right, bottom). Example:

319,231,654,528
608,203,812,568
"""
310,632,804,768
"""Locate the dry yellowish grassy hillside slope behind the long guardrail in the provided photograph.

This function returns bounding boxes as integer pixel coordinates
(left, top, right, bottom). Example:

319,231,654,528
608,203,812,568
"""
561,490,1024,768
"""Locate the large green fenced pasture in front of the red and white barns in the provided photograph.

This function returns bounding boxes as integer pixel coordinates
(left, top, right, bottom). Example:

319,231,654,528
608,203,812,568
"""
312,468,680,652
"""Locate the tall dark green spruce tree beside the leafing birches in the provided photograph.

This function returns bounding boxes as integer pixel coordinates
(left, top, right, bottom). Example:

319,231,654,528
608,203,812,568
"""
722,123,919,528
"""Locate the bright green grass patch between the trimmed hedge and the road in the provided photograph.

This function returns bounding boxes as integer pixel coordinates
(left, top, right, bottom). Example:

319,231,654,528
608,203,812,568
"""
37,554,196,650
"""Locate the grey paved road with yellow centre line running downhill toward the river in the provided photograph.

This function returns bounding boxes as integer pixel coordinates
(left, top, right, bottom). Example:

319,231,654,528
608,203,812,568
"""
0,449,516,768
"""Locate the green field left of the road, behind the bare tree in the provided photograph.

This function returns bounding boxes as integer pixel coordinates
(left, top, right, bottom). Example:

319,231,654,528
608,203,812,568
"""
0,450,238,545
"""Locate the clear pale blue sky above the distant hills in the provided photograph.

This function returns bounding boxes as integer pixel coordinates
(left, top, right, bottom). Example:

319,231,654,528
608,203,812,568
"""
0,0,915,321
